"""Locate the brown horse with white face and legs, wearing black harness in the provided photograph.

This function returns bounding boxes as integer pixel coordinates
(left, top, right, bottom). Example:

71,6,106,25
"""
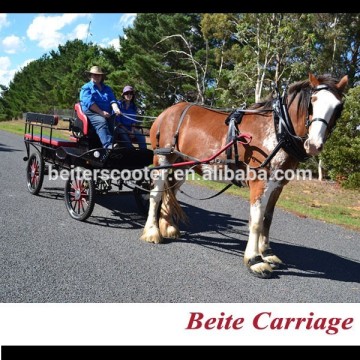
140,73,348,278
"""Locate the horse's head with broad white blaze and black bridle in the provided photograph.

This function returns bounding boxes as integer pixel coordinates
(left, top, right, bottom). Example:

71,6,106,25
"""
304,74,348,156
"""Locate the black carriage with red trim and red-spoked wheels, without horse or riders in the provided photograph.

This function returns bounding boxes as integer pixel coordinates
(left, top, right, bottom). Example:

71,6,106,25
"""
24,103,153,221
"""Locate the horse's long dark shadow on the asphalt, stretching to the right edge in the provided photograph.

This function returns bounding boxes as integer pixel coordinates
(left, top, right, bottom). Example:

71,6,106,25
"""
168,204,360,283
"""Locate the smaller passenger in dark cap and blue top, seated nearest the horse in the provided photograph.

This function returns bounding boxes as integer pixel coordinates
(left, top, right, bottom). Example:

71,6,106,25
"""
116,85,147,149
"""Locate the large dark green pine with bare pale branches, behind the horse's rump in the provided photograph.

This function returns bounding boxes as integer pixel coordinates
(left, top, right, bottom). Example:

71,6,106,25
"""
113,14,225,115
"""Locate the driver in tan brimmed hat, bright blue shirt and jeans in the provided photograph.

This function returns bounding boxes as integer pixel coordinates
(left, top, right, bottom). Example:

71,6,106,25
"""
80,66,121,149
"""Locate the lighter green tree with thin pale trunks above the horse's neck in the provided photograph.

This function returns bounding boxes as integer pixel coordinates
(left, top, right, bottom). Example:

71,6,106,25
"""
230,13,314,102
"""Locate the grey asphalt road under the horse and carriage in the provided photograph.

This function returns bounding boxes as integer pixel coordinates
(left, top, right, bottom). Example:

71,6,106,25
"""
0,131,360,303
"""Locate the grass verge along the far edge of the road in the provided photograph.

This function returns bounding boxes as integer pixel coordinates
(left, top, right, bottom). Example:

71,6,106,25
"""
0,120,360,231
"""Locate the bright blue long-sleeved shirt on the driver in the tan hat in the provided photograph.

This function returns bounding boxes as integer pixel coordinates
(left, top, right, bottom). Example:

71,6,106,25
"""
80,81,116,114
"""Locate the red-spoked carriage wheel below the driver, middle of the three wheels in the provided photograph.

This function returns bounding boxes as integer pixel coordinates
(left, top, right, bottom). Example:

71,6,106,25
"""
64,167,95,221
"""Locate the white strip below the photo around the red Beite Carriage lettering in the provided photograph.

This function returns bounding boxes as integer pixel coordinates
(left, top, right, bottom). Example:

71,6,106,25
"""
0,303,360,345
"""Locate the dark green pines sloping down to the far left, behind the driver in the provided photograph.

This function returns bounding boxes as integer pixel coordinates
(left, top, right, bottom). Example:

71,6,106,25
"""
1,40,114,119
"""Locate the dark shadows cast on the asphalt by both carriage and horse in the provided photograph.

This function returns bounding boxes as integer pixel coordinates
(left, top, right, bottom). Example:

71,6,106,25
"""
33,188,360,283
